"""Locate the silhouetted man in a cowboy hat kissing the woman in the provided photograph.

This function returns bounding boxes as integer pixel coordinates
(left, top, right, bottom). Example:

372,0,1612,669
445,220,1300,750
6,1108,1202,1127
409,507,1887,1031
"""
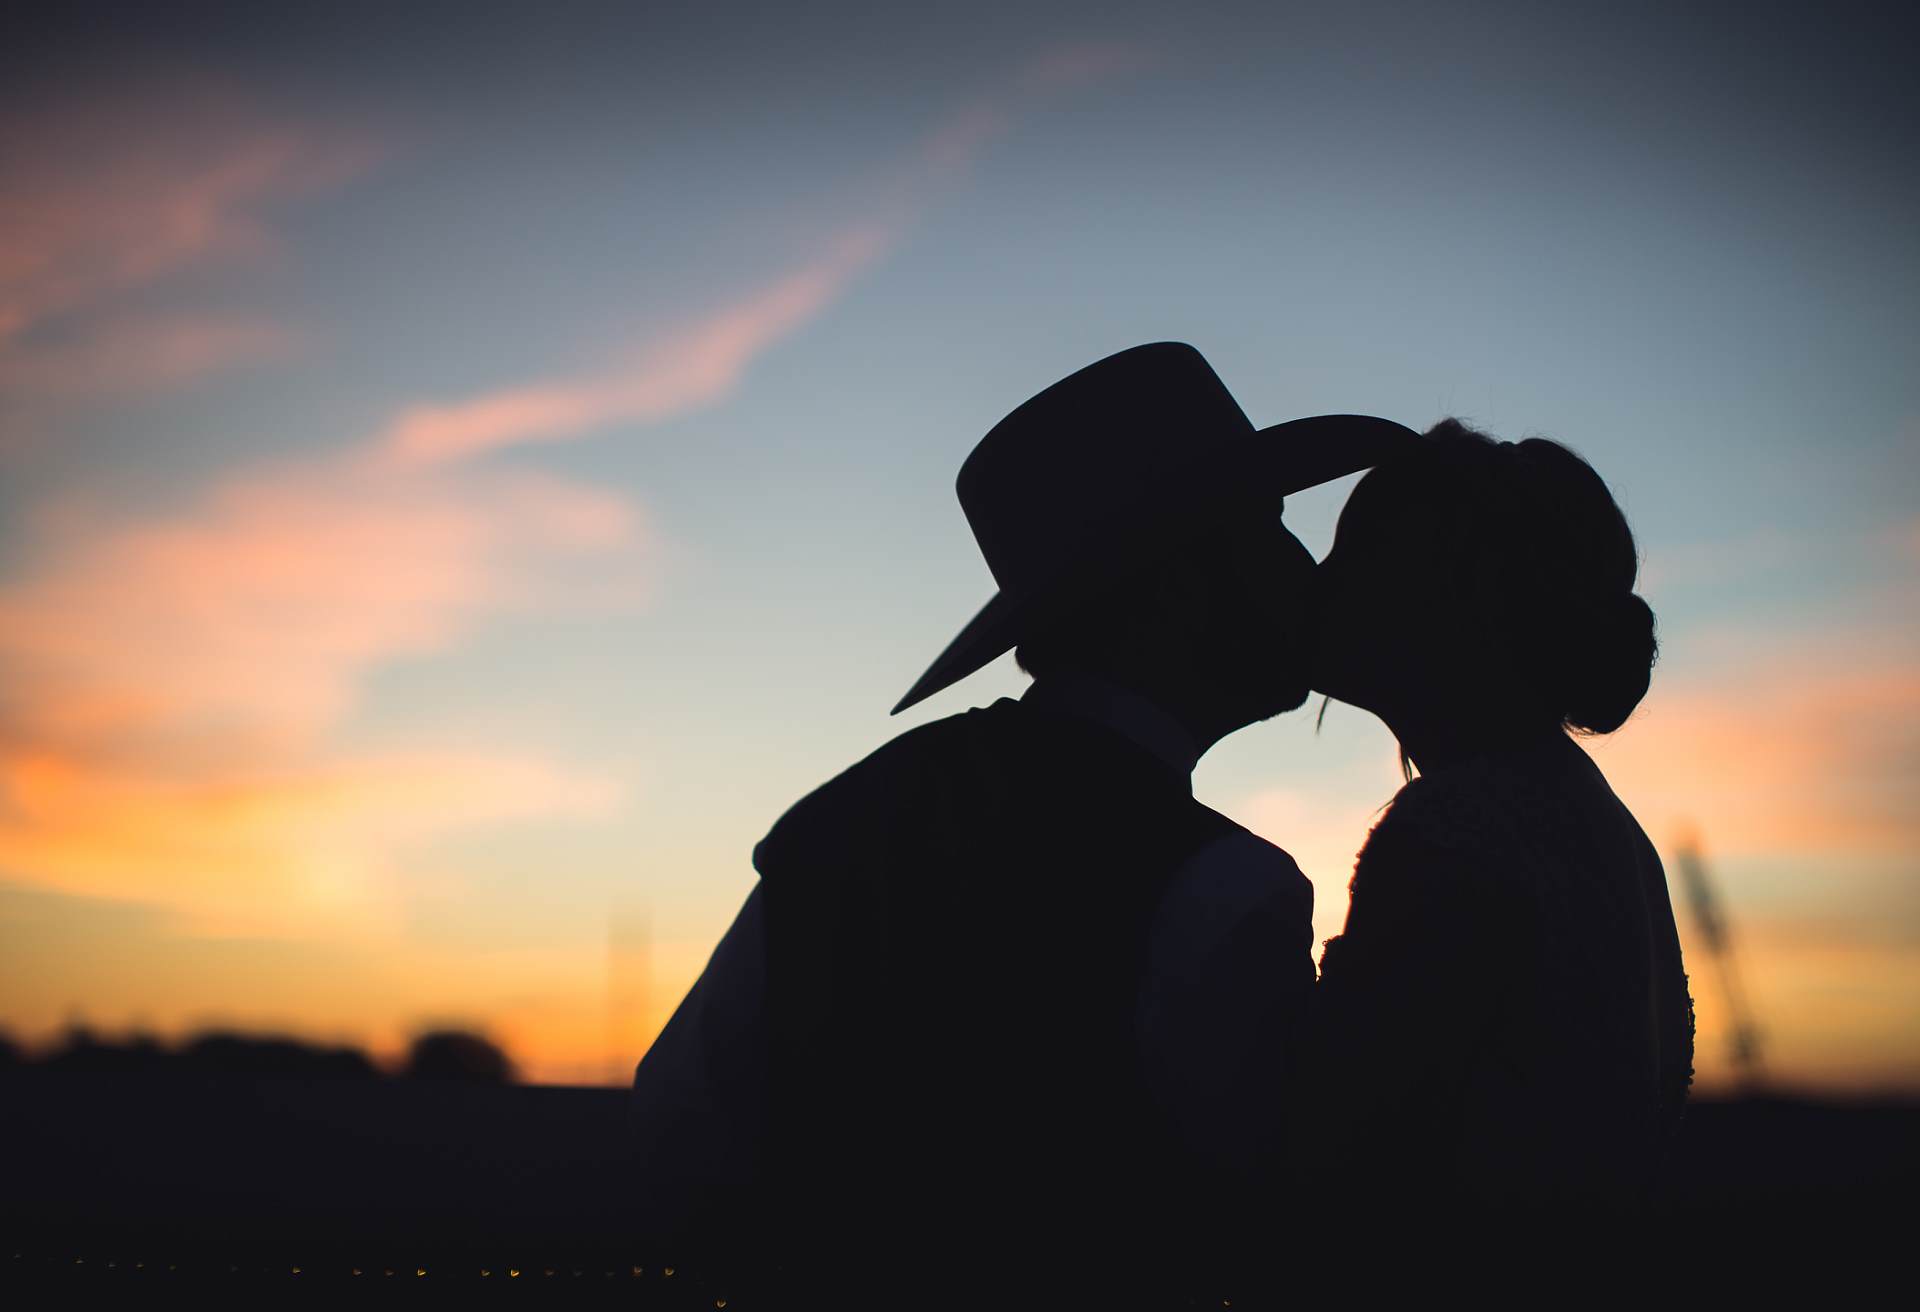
636,342,1417,1272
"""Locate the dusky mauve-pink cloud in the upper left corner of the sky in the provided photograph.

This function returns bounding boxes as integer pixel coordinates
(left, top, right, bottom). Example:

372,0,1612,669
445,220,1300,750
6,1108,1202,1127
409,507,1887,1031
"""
0,81,378,405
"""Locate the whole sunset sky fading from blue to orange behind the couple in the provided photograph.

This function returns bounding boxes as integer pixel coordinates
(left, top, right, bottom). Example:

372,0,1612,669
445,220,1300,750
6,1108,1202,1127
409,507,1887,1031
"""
0,4,1920,1091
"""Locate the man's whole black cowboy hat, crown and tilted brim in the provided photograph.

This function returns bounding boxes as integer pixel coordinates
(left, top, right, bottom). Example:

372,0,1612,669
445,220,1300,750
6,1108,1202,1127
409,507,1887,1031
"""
893,342,1419,715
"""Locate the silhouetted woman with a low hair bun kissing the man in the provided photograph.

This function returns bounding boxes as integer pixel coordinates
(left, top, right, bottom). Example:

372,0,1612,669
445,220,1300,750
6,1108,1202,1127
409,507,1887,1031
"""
1294,419,1693,1220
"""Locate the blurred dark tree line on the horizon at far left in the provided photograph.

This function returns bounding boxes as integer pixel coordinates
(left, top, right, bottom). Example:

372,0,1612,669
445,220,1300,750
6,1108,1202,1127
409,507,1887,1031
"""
0,1024,518,1083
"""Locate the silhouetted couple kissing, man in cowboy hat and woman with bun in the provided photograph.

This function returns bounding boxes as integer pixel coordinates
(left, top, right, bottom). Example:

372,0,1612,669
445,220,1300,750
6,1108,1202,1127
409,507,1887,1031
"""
636,344,1692,1283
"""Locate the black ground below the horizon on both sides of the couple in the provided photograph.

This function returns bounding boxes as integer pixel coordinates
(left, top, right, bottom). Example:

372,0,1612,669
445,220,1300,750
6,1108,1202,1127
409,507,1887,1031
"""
0,1070,1920,1308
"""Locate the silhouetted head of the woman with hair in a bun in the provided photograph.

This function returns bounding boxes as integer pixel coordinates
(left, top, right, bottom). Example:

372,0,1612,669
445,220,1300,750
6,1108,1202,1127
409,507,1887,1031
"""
1313,419,1657,749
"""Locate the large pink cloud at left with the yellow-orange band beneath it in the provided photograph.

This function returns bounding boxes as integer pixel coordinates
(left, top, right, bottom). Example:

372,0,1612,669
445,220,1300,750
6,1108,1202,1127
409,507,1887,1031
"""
0,451,643,934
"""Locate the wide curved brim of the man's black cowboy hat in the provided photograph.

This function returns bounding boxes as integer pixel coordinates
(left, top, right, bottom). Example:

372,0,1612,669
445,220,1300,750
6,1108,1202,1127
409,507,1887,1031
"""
889,415,1421,715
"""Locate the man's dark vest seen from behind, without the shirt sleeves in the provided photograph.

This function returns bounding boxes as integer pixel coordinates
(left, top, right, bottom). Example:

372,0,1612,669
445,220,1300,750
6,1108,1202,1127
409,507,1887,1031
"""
755,701,1235,1262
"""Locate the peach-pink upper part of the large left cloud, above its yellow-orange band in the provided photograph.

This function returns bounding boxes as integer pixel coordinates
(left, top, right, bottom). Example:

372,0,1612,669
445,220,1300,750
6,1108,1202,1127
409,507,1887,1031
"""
0,457,637,736
